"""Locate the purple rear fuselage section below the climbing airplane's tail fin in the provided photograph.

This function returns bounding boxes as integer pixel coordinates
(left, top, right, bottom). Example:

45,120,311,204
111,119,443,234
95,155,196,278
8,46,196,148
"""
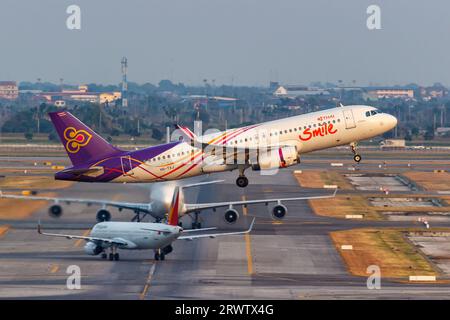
55,141,182,182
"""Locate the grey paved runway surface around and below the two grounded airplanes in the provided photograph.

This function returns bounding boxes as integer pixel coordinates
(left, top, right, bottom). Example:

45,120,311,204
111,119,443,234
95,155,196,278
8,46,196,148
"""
0,165,450,299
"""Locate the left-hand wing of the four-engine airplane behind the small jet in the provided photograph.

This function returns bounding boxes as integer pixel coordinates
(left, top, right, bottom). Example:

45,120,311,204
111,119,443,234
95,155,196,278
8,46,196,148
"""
0,191,152,213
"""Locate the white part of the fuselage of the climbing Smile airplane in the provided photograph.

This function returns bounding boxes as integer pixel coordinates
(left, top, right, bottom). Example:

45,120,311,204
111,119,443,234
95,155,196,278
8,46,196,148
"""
114,105,397,182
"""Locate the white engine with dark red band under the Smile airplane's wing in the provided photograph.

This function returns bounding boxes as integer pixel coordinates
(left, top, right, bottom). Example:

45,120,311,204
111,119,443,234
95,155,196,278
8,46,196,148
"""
252,146,299,171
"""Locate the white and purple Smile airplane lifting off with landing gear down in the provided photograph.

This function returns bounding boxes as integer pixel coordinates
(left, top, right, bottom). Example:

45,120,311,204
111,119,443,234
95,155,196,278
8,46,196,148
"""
49,105,397,187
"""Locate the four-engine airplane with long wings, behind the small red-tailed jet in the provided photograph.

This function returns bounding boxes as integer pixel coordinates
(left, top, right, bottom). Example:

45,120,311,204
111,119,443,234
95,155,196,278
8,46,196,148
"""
0,180,337,229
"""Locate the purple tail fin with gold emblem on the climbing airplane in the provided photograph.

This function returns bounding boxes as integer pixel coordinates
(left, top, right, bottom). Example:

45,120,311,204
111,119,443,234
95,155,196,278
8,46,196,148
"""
49,111,122,165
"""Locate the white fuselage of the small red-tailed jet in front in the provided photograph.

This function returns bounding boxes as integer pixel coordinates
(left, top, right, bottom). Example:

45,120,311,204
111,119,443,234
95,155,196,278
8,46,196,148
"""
90,222,183,250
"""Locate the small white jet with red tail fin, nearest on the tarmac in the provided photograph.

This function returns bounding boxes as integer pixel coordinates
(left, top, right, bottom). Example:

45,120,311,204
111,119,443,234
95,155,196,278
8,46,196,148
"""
38,186,255,261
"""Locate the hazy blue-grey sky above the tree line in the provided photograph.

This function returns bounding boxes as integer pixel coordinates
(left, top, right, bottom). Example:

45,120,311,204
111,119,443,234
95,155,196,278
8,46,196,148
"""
0,0,450,85
